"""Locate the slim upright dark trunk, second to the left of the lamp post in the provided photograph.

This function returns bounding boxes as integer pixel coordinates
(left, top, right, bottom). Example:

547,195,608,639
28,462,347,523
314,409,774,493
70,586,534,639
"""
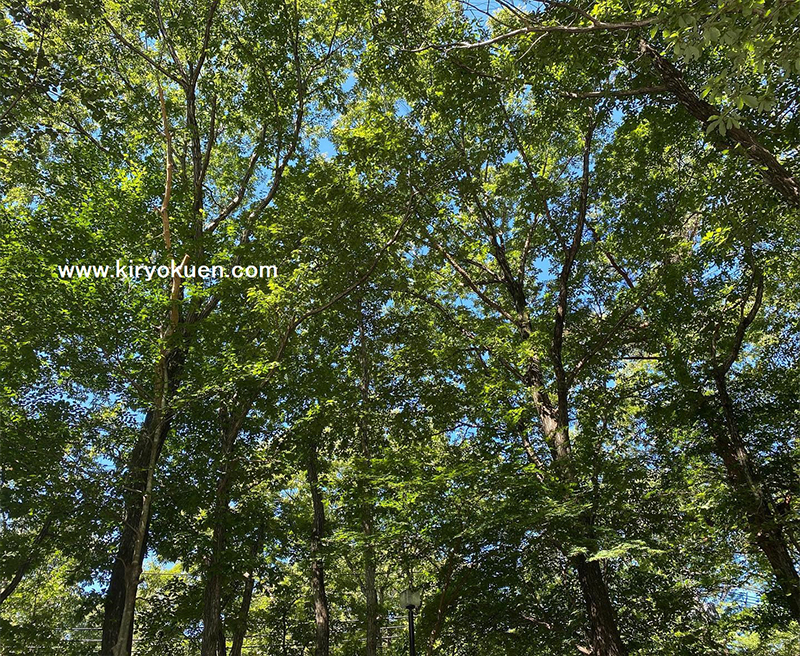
307,440,330,656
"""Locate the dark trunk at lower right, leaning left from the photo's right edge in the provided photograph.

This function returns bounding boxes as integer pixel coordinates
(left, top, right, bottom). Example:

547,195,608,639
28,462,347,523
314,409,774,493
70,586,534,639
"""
714,371,800,620
